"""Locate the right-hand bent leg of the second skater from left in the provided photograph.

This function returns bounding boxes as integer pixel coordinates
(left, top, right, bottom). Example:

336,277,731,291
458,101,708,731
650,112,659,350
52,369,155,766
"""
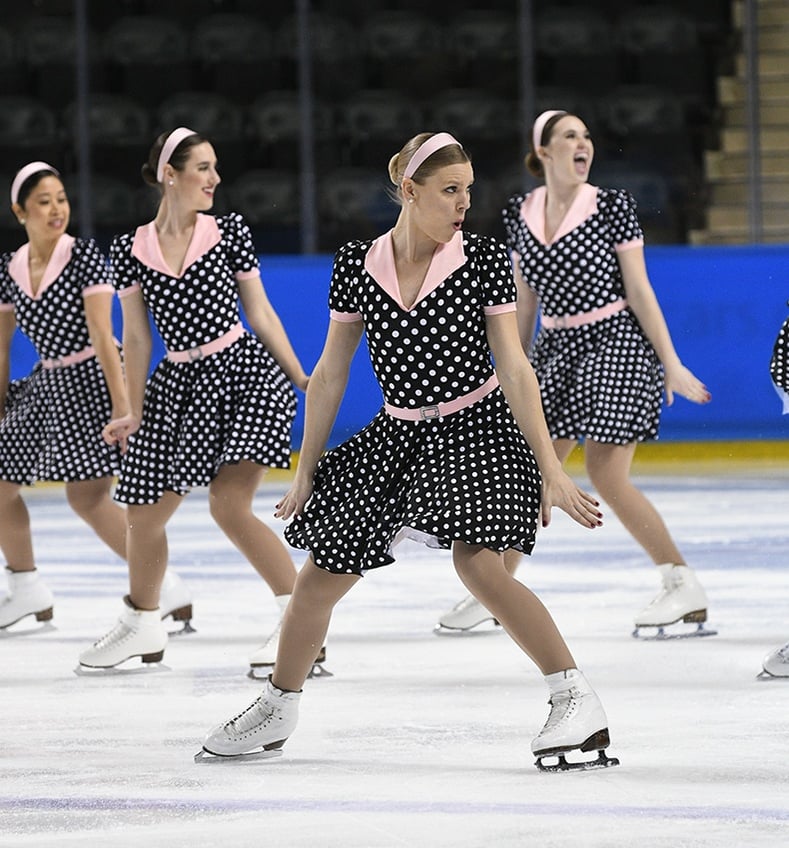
210,462,296,592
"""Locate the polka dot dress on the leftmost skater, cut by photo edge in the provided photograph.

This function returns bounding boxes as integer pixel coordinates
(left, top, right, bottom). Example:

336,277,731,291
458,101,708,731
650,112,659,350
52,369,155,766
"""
0,235,120,485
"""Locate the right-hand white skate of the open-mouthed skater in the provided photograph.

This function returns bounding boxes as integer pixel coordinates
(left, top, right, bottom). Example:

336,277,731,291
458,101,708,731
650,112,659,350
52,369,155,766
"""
633,563,717,639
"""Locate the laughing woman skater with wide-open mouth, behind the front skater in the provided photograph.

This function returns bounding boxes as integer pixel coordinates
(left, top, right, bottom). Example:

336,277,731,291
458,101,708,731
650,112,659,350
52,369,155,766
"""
439,110,713,636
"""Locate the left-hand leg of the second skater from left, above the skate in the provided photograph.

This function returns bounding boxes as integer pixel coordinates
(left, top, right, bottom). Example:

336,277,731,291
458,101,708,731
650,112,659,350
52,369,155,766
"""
126,492,183,610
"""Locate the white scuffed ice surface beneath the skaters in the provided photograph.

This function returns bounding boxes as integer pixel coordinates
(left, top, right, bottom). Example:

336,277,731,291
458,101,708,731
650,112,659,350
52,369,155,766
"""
0,466,789,848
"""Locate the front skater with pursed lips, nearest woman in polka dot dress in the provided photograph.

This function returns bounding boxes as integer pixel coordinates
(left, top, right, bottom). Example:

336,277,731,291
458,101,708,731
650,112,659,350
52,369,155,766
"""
198,133,616,768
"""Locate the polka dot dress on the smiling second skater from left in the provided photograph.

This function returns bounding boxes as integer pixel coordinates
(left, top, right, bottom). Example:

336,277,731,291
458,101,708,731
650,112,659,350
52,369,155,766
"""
110,214,296,504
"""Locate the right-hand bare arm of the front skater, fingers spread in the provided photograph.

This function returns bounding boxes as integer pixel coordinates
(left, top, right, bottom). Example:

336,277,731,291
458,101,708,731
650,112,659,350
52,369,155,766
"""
487,312,602,528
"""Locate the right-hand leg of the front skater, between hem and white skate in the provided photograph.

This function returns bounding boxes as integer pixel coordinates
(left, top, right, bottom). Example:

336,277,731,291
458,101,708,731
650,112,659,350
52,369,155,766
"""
456,542,576,674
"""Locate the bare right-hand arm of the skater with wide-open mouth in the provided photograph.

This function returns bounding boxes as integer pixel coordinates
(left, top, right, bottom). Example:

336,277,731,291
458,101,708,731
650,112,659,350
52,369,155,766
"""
617,247,712,406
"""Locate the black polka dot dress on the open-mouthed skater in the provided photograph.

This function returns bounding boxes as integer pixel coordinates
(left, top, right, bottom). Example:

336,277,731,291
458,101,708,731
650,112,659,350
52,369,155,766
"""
503,184,663,444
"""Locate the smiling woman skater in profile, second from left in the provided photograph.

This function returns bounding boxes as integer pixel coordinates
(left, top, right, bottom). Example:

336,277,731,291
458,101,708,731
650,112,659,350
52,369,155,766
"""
79,127,308,668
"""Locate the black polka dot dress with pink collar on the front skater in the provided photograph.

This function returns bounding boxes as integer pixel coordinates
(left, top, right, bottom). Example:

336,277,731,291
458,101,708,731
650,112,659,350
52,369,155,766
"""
285,233,540,574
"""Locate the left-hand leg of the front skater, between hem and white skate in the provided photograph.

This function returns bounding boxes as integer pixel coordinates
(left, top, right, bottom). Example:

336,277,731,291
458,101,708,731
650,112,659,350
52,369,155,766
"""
271,556,361,692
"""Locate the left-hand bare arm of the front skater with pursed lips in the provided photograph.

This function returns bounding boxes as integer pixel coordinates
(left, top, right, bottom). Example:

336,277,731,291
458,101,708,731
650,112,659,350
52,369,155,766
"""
274,321,363,518
